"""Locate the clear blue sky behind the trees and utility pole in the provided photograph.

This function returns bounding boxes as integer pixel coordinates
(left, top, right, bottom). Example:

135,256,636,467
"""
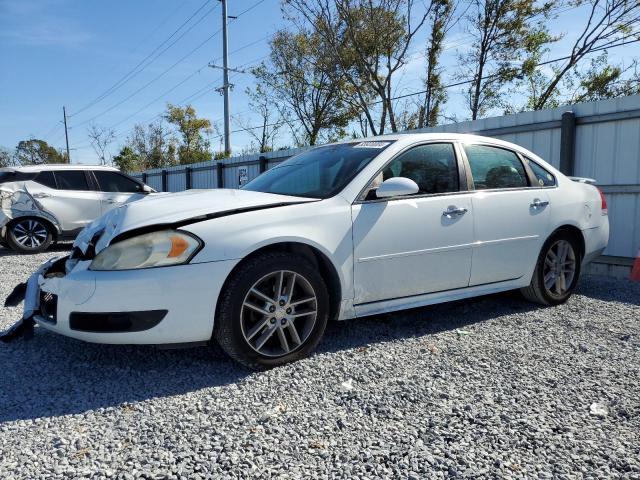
0,0,634,163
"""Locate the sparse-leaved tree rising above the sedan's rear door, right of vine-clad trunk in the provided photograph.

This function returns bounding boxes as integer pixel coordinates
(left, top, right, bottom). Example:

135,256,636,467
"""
460,0,556,120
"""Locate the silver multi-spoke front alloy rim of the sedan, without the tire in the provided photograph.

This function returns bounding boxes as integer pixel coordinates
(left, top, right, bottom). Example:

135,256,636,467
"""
240,270,318,357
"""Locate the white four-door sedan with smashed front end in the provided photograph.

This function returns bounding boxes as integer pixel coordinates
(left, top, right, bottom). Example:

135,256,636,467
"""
2,134,609,368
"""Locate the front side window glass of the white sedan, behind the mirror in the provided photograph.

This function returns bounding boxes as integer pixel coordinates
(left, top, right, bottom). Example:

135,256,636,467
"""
371,143,460,195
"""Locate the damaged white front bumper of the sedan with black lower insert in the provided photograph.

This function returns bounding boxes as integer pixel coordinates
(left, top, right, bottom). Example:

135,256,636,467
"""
13,259,237,344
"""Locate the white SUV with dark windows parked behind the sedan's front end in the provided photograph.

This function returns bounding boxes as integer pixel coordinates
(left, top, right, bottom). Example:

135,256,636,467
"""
0,165,154,253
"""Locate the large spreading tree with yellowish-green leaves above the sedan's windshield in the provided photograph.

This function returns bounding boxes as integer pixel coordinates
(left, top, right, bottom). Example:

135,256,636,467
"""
286,0,432,135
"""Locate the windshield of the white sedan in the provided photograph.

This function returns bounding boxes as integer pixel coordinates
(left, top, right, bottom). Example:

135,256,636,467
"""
242,140,393,198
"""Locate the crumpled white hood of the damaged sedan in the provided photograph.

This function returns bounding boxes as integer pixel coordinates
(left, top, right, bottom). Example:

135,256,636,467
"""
74,189,317,254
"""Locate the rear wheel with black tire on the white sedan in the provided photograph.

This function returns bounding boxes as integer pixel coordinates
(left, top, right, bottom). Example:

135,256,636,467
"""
520,231,582,305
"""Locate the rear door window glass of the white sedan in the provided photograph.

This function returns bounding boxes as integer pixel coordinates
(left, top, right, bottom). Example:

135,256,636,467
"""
464,144,529,190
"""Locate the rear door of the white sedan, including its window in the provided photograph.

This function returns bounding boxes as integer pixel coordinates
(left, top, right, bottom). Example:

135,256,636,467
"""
463,143,551,286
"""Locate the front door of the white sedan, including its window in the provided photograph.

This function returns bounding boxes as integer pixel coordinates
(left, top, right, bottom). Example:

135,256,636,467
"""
352,143,473,304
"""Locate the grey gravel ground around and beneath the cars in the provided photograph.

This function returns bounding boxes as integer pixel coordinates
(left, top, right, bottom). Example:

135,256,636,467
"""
0,247,640,479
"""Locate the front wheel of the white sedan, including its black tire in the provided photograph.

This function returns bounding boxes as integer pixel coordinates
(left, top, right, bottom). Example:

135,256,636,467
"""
213,252,329,370
